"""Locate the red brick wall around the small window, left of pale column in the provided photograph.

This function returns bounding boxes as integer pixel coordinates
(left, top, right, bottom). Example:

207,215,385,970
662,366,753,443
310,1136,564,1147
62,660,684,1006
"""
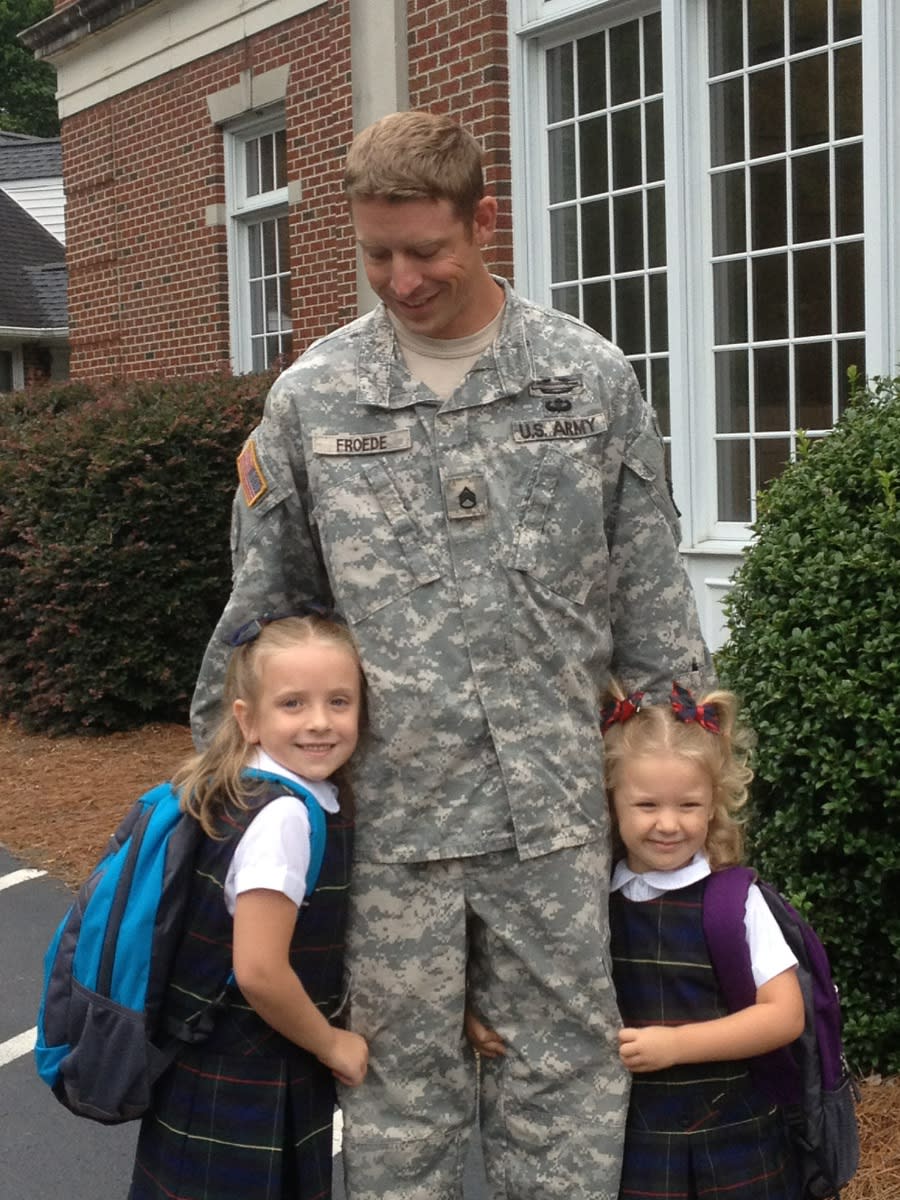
62,0,355,378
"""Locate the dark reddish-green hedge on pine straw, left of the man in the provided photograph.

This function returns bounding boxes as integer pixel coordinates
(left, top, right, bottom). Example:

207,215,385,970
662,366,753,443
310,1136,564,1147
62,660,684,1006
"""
0,376,271,733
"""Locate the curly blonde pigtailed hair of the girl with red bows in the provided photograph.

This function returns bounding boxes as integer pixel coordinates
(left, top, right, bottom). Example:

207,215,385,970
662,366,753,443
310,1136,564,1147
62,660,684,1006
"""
604,684,754,870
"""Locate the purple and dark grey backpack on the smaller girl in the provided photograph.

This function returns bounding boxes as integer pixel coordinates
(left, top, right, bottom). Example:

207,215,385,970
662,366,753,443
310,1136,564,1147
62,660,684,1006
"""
703,866,859,1200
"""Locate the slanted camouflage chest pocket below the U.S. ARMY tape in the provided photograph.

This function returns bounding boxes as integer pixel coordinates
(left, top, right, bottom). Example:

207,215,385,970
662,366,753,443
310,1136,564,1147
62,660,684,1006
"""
510,446,608,605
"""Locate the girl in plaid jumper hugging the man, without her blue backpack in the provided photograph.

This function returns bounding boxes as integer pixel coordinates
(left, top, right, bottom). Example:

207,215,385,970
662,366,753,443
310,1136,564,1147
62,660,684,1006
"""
130,613,368,1200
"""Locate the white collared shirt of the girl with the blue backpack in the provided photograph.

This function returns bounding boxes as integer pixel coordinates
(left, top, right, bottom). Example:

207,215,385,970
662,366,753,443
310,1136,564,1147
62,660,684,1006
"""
224,750,338,916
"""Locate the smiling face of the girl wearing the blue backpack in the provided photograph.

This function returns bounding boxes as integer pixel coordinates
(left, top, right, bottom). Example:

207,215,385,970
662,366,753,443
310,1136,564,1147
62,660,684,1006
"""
234,641,361,780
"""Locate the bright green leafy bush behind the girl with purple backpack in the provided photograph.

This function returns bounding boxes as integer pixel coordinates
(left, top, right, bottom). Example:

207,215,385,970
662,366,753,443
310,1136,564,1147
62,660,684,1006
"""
716,369,900,1073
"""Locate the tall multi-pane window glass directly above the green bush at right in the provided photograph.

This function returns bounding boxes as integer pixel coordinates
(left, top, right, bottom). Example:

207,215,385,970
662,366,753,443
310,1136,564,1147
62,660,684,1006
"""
707,0,865,522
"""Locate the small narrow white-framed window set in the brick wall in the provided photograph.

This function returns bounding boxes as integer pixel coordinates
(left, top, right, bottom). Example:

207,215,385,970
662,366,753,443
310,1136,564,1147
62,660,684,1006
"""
227,119,293,371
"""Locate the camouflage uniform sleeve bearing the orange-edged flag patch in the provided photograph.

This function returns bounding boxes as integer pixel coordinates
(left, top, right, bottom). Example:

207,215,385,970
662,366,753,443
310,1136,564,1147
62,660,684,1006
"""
191,380,330,749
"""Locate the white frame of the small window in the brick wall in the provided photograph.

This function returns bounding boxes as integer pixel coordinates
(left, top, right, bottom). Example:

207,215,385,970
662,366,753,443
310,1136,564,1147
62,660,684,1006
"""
223,106,289,373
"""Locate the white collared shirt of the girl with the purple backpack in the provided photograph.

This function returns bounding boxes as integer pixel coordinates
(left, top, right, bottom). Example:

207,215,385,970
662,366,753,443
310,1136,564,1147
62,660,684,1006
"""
610,851,797,988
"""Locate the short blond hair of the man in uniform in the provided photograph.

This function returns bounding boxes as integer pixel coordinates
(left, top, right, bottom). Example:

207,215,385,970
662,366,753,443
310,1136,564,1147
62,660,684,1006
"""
343,109,485,222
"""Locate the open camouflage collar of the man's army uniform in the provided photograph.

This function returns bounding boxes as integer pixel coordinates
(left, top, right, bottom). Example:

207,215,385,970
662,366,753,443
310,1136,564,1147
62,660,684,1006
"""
356,275,534,413
